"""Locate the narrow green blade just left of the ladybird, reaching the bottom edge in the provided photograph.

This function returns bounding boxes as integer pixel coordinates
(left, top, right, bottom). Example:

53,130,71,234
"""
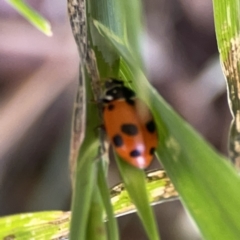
70,72,100,240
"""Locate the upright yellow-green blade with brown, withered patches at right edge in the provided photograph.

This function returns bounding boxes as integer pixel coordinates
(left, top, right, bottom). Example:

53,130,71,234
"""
213,0,240,171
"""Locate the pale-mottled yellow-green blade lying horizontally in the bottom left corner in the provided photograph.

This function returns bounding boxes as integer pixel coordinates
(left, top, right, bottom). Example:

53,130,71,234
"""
0,211,71,240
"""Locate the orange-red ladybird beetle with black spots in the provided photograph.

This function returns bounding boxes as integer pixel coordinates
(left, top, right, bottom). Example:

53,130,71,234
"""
102,79,158,169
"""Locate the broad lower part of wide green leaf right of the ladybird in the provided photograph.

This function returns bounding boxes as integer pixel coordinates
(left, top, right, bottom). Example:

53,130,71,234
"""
153,88,240,239
